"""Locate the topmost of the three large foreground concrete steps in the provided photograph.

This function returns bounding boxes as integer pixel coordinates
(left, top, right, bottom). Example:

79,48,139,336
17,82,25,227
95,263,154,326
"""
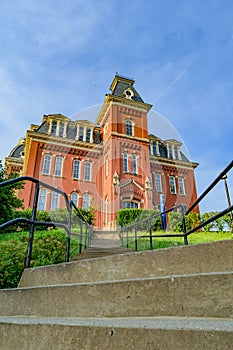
20,240,233,287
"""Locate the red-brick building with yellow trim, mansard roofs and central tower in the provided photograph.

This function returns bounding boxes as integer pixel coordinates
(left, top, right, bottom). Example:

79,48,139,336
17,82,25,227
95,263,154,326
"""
6,75,198,228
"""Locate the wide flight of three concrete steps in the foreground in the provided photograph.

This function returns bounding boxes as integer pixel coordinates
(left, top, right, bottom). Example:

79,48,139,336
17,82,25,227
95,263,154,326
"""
0,240,233,350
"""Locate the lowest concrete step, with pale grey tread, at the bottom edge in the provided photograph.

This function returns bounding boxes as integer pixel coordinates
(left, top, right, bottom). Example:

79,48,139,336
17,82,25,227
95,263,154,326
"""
0,317,233,350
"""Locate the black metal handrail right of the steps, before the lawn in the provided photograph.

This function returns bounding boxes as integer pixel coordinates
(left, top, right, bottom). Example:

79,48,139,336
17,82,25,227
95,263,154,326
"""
118,161,233,250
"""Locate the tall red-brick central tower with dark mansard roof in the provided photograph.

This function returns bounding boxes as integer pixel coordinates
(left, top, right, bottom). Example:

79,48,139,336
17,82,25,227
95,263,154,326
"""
96,74,152,229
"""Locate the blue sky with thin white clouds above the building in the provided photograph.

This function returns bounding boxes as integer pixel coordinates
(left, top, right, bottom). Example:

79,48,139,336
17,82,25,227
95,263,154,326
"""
0,0,233,211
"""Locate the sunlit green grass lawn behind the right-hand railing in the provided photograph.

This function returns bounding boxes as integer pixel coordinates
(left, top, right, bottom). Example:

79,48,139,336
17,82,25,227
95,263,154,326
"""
124,232,233,251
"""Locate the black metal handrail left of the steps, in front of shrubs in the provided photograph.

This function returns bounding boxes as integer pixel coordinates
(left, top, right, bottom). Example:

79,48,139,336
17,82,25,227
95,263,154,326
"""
0,176,93,268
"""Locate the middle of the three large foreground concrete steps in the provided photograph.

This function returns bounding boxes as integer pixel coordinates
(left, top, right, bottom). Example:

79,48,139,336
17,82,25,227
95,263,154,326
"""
0,272,233,318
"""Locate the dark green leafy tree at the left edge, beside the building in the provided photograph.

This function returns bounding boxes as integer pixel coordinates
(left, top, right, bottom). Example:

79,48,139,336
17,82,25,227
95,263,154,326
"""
0,160,23,225
